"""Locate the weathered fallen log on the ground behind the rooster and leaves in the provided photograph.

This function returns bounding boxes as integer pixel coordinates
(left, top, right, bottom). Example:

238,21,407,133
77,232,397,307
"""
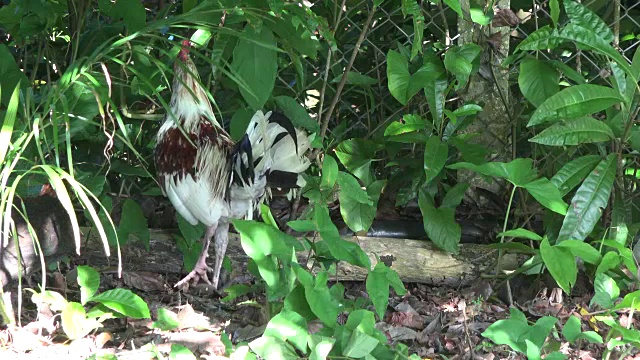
81,228,519,286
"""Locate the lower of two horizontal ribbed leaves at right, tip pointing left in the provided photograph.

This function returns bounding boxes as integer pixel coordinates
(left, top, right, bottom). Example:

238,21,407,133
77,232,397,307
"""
529,117,615,146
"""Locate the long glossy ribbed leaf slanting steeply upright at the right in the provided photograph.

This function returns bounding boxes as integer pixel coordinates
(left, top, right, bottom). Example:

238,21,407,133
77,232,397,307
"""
558,154,617,241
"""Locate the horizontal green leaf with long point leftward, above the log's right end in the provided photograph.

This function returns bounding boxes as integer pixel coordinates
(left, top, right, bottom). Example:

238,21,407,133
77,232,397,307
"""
447,158,538,186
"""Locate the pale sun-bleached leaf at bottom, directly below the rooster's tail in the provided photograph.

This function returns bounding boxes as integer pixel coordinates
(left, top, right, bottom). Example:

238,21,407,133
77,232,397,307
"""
264,309,309,353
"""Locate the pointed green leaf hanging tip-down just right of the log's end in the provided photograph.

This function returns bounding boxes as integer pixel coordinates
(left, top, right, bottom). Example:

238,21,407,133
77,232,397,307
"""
540,238,578,294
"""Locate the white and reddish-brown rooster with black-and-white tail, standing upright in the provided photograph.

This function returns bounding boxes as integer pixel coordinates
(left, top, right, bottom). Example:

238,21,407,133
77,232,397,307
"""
155,40,310,288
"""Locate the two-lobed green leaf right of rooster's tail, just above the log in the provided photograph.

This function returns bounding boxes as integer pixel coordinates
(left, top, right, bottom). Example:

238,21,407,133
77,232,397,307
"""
340,180,386,232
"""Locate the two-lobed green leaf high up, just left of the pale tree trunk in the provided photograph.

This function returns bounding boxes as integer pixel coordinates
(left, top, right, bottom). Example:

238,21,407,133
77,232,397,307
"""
387,50,434,105
